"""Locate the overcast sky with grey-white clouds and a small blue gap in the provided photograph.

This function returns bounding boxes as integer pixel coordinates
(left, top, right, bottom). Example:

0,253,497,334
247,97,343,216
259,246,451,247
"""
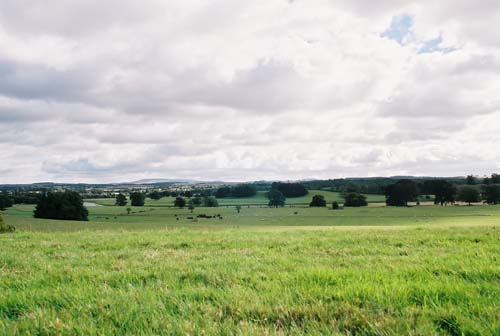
0,0,500,183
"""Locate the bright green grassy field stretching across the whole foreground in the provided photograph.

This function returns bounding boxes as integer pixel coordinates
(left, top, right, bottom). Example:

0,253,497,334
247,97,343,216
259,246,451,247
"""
0,206,500,335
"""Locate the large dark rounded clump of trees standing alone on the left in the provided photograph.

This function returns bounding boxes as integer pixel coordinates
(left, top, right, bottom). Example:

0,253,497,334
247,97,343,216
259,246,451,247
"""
34,191,89,221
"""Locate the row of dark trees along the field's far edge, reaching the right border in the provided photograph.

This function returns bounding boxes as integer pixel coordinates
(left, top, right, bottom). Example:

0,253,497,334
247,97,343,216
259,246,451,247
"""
384,179,500,206
